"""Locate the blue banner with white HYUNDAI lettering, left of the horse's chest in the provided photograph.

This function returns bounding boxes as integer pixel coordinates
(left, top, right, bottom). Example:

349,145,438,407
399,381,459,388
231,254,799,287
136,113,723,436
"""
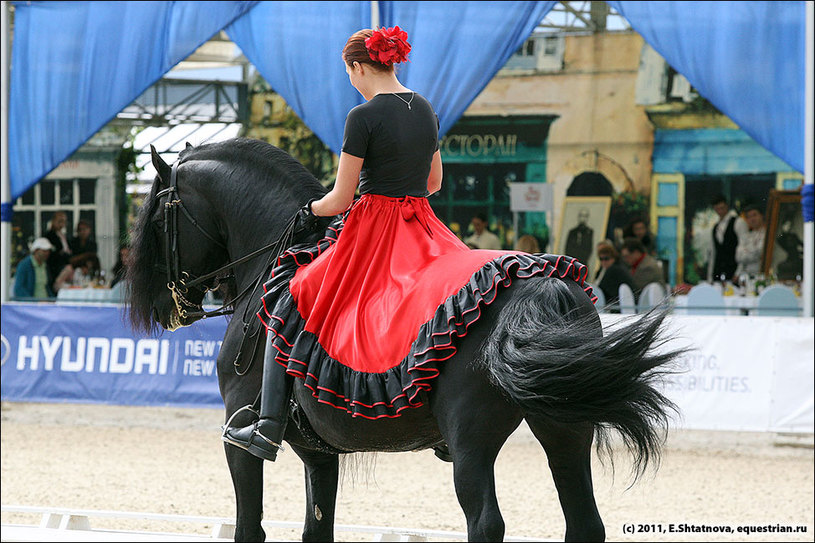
0,304,226,407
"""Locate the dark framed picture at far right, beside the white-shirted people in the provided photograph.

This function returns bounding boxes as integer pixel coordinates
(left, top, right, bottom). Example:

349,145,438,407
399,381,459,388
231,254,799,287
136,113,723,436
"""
761,189,804,281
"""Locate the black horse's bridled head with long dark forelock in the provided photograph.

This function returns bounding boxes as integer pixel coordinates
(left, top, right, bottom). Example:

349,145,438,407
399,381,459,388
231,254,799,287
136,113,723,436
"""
127,144,228,331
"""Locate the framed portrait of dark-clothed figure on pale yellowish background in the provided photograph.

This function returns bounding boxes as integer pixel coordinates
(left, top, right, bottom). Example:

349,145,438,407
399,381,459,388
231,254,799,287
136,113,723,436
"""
555,196,611,276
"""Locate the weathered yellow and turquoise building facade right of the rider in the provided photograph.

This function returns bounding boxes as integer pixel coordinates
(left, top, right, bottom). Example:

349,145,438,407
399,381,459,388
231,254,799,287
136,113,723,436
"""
460,30,803,285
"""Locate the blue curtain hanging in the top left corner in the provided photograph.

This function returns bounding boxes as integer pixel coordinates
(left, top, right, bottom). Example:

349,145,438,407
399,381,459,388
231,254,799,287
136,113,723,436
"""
9,1,257,201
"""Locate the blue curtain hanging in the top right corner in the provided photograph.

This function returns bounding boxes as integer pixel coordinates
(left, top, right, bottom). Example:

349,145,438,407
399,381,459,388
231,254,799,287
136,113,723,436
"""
608,1,806,173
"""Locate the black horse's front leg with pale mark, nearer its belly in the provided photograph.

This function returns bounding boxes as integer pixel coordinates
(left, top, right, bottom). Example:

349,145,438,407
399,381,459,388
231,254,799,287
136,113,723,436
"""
291,445,340,541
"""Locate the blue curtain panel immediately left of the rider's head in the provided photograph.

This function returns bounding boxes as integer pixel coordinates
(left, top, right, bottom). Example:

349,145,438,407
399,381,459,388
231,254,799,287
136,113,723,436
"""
226,1,371,154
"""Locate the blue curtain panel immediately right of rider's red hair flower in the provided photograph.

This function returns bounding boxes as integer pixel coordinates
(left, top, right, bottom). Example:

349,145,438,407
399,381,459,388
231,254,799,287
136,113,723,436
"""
379,1,556,140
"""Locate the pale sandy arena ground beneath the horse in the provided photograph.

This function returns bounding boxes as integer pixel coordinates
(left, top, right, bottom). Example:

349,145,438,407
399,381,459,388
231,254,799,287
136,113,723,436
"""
0,403,815,541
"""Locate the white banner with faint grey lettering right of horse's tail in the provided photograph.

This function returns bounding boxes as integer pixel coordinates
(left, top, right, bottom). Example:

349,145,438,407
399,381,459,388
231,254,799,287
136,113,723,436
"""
602,315,815,433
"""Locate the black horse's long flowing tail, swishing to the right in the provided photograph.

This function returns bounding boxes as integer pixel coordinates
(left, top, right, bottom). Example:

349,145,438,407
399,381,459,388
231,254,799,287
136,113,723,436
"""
482,279,683,479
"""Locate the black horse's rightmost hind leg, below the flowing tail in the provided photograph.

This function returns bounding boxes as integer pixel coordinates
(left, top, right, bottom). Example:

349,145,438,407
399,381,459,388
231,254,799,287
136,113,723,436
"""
527,417,606,541
